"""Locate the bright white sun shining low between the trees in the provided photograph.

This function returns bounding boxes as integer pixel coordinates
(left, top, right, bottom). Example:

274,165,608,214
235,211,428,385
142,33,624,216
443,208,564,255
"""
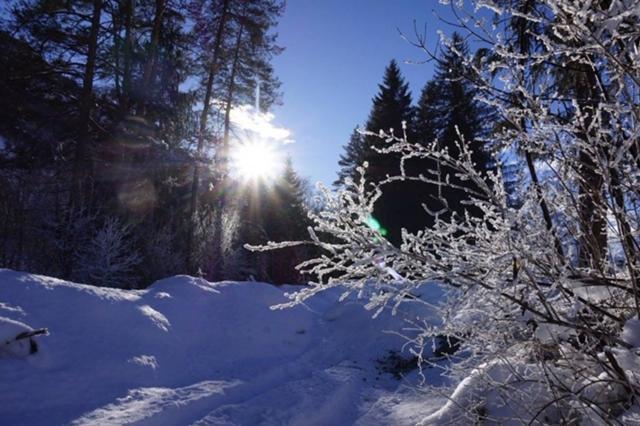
231,141,282,180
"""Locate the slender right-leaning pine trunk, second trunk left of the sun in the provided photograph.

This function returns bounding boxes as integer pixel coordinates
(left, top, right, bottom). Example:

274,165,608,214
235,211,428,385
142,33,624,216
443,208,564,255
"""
187,0,231,273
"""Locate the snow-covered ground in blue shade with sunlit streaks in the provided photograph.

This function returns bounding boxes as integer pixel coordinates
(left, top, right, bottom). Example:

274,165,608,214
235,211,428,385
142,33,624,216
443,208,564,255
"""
0,270,445,425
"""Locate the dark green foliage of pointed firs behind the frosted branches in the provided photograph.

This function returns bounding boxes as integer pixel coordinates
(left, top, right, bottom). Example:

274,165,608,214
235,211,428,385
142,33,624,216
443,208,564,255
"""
335,33,494,244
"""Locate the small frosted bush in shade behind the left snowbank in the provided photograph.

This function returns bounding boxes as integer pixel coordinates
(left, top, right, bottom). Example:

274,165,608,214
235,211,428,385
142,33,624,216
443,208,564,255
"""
74,218,140,288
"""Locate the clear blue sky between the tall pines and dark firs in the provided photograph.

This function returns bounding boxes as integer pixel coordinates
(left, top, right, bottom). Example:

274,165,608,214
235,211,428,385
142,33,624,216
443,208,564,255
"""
273,0,458,184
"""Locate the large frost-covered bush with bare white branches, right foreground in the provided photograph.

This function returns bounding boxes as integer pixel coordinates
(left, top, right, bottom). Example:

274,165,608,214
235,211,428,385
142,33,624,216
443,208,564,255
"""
252,0,640,424
